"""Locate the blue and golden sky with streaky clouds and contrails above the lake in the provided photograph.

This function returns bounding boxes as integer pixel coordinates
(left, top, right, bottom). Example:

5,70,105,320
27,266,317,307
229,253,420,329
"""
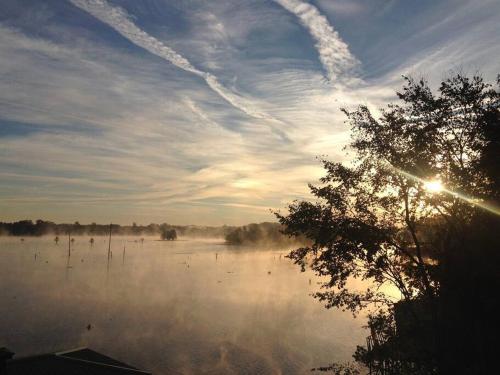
0,0,500,225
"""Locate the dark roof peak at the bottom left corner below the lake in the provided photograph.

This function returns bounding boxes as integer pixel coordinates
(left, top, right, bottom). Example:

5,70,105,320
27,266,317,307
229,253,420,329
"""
6,348,151,375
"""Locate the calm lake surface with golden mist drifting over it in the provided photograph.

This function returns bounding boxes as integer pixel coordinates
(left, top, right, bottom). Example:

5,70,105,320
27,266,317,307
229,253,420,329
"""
0,236,366,374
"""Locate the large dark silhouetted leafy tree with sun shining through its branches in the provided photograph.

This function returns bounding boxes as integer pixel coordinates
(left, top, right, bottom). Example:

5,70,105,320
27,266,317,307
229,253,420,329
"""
277,75,500,373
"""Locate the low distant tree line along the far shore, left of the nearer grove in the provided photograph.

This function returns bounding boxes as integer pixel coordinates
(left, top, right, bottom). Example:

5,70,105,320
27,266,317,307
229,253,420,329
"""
0,220,236,238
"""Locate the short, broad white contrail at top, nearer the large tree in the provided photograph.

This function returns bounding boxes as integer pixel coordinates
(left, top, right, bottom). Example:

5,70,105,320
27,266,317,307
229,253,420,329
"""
275,0,359,81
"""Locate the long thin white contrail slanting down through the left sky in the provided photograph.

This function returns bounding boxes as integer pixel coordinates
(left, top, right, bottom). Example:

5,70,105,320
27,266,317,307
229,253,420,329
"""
70,0,273,120
